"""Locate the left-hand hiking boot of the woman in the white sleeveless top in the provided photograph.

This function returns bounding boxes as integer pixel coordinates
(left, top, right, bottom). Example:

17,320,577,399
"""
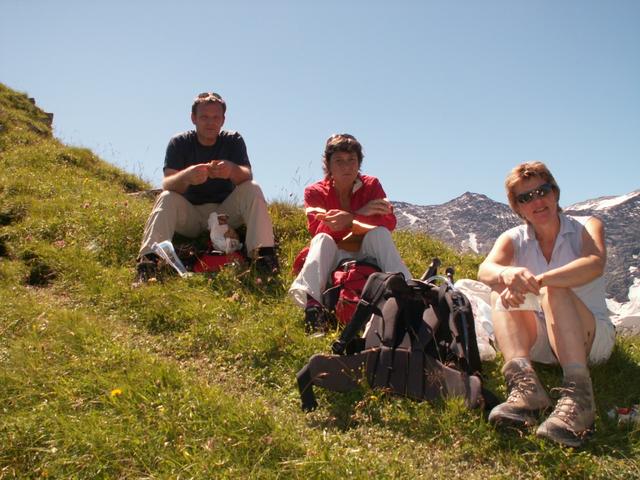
489,358,551,427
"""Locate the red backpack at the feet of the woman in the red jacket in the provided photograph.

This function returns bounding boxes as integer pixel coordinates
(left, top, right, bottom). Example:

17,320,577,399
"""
322,260,380,325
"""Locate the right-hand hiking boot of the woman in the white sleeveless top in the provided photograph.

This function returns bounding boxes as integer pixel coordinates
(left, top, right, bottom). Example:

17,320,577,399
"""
536,375,596,447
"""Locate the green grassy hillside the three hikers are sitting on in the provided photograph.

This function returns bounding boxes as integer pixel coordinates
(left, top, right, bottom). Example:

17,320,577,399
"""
0,84,640,479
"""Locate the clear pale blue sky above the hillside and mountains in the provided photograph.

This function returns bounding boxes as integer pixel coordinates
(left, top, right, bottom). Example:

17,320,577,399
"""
0,0,640,206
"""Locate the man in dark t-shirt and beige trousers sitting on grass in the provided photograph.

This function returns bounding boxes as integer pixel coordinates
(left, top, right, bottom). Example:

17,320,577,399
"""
138,92,278,281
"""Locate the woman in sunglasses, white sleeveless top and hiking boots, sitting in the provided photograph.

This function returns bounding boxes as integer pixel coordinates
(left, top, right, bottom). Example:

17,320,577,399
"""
478,162,615,447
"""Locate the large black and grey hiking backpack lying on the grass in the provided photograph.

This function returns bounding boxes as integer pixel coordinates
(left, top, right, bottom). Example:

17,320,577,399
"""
297,262,497,411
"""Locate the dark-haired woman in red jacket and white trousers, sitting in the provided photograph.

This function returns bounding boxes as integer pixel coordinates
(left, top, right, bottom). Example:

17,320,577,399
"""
289,133,411,329
